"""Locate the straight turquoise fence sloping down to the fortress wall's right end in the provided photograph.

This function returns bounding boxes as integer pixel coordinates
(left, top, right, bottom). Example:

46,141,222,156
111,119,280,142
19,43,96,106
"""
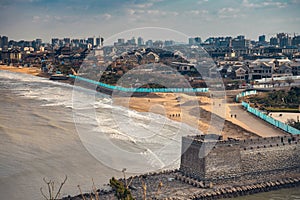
242,102,300,135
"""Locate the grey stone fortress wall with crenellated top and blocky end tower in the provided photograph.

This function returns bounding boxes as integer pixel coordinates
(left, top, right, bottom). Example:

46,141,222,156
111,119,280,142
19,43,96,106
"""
180,135,300,183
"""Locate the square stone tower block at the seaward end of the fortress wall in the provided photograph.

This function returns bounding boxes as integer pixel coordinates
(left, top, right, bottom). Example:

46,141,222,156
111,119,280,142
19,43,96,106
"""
180,135,241,182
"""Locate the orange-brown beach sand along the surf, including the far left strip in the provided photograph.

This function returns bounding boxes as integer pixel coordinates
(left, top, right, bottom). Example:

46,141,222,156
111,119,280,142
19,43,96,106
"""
0,65,257,139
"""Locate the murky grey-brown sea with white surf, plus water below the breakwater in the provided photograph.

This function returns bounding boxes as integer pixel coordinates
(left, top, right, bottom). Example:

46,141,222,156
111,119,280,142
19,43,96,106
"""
0,70,300,200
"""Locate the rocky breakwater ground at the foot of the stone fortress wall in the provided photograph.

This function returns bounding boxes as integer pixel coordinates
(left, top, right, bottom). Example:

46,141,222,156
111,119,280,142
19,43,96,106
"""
63,169,300,200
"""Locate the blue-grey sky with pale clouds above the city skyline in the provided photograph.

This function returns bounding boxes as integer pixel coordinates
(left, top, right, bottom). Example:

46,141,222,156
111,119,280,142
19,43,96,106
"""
0,0,300,42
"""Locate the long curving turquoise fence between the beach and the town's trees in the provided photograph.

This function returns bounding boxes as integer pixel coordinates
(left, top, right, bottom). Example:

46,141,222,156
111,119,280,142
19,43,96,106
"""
69,74,208,93
